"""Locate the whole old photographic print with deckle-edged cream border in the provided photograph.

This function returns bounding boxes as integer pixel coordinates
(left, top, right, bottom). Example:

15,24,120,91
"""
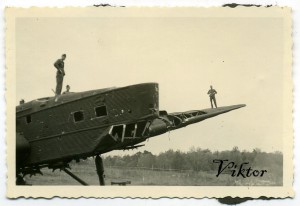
6,7,293,197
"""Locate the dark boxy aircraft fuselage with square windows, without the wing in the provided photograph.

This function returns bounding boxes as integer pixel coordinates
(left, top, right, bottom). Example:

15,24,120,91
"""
16,83,159,169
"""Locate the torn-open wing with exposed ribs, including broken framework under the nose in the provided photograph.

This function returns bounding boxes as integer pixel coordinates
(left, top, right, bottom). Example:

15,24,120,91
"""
94,104,246,153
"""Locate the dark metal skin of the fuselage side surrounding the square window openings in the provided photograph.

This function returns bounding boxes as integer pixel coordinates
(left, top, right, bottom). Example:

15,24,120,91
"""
17,83,158,164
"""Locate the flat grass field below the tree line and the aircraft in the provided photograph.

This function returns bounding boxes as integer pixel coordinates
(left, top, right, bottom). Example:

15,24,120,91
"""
26,160,282,186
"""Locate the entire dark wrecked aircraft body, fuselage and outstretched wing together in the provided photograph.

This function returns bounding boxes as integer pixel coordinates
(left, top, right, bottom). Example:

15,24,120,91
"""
16,83,245,172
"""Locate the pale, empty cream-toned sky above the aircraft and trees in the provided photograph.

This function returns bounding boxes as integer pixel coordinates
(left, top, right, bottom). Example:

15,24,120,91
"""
15,9,285,154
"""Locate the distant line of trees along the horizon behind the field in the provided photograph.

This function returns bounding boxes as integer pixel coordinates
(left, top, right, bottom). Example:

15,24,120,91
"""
103,147,283,173
